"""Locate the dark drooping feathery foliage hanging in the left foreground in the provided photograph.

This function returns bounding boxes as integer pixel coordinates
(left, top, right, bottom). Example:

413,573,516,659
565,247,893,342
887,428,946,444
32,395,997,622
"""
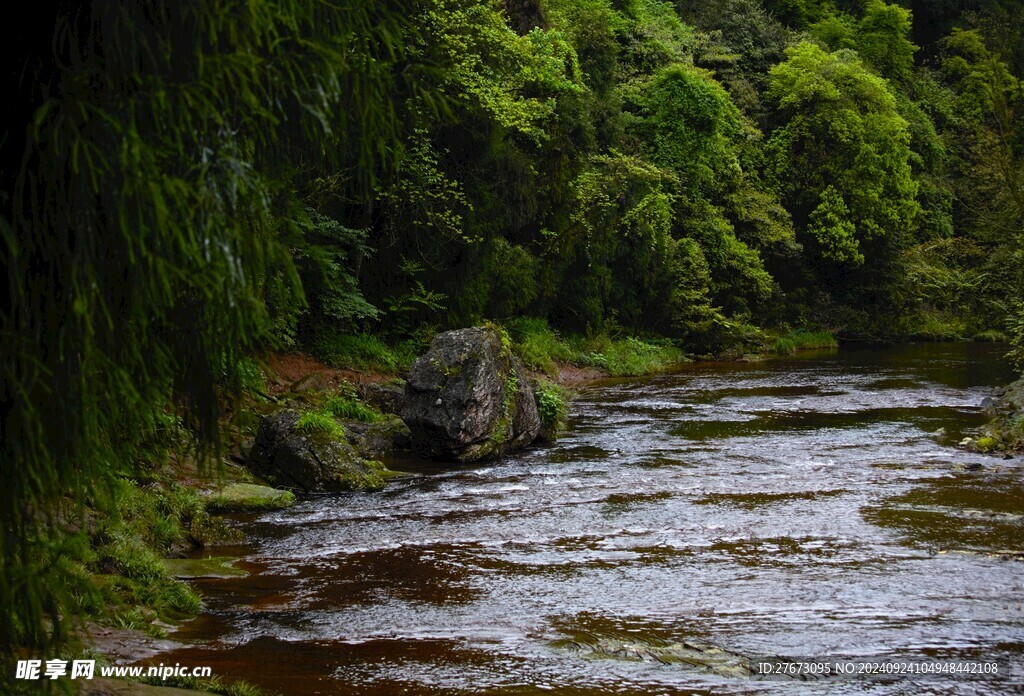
0,0,428,649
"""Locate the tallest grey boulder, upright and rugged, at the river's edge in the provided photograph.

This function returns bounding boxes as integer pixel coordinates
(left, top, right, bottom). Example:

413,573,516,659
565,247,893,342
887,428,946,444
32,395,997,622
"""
401,328,541,462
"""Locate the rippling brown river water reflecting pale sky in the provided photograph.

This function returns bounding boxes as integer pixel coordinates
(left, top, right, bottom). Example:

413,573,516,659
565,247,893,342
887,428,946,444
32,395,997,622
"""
154,344,1024,695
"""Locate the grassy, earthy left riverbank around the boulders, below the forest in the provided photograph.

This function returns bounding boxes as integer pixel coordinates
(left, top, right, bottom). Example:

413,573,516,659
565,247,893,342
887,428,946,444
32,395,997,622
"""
44,319,909,693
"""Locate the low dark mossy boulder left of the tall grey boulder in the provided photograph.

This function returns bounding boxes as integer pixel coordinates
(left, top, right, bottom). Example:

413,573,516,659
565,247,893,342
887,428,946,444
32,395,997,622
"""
248,410,390,492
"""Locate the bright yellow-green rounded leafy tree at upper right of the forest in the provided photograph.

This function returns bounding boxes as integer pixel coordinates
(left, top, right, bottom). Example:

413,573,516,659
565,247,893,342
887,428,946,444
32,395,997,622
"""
767,42,921,290
